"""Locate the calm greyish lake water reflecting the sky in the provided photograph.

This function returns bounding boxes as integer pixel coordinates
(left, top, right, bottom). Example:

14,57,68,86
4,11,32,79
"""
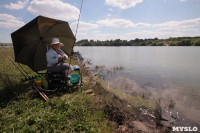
75,46,200,125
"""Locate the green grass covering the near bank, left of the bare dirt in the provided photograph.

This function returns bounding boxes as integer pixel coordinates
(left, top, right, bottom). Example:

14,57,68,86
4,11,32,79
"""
0,48,113,133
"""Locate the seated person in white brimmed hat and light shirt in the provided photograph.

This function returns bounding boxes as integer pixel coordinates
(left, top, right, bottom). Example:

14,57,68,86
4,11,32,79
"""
46,38,73,79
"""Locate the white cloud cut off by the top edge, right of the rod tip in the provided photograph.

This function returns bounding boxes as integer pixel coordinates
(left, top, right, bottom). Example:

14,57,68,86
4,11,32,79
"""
106,0,143,9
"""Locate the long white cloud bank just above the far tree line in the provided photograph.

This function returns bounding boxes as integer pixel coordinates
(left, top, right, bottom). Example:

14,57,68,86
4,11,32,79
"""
79,18,200,41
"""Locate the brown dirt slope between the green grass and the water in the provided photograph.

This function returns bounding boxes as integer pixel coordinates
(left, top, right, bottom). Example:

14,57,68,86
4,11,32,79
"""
74,54,171,133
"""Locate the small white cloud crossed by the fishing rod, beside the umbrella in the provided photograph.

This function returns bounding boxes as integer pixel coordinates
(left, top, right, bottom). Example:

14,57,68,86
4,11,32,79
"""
70,21,99,31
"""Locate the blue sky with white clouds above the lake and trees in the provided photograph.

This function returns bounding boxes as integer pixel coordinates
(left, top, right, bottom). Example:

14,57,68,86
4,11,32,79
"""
0,0,200,43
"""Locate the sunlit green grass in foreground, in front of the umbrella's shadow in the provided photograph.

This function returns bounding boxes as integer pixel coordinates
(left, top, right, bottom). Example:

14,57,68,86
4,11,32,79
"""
0,94,111,133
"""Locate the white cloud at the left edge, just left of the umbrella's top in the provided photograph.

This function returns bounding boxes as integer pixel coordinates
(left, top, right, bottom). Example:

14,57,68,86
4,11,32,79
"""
0,14,25,28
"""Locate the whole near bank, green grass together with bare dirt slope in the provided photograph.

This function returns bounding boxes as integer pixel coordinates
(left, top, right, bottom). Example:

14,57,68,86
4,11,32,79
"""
0,48,168,133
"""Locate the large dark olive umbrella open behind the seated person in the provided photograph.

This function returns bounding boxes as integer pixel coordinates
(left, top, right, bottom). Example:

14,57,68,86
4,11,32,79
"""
11,16,75,71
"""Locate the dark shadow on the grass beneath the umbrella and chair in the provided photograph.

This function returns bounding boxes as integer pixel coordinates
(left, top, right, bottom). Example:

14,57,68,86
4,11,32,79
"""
0,77,80,108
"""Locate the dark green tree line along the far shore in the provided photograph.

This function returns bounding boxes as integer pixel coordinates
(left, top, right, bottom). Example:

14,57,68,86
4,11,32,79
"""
75,36,200,46
